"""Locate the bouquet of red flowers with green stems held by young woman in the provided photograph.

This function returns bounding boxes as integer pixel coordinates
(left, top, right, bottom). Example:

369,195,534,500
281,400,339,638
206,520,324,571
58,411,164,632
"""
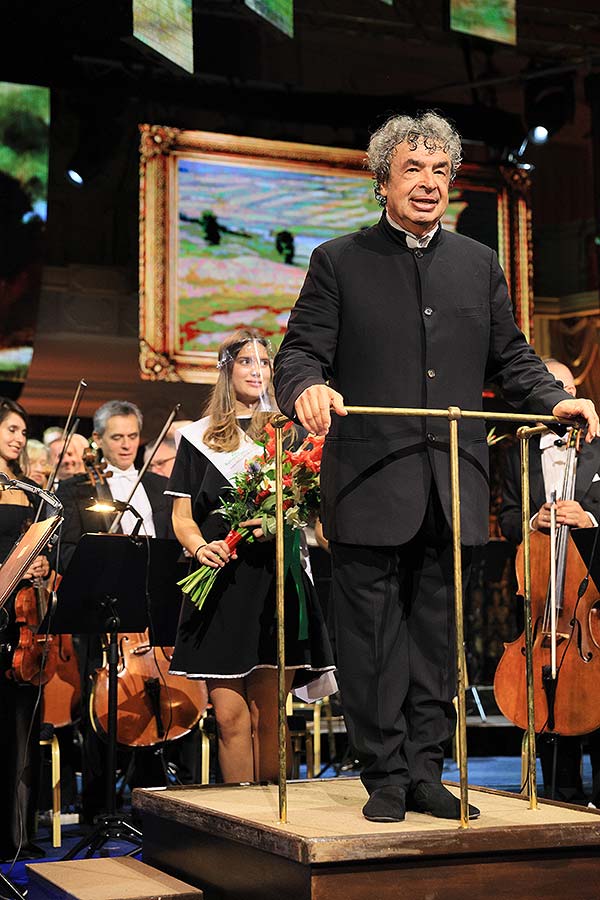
178,422,325,609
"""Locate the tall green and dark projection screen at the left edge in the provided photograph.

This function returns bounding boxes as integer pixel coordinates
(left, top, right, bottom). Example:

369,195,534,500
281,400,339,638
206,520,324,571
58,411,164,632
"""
0,82,50,382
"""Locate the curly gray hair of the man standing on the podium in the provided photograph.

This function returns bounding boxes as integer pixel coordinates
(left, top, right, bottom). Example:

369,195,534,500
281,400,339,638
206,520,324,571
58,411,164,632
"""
367,110,462,206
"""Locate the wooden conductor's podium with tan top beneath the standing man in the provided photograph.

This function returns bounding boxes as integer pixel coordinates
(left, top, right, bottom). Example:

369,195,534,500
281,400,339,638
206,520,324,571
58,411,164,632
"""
134,778,600,900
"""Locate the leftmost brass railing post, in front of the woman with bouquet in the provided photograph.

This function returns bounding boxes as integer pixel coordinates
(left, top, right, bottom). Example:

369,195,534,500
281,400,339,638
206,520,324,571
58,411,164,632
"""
274,416,287,824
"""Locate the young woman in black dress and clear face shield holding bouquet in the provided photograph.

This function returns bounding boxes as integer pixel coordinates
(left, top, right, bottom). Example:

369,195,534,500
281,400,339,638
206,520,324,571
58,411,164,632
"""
167,329,335,782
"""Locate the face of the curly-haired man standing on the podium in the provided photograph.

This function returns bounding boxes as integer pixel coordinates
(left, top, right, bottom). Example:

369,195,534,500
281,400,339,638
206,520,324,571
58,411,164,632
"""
380,140,450,237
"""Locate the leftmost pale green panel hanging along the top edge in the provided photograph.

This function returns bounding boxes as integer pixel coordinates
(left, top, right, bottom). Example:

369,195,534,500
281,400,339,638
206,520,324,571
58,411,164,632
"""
133,0,194,72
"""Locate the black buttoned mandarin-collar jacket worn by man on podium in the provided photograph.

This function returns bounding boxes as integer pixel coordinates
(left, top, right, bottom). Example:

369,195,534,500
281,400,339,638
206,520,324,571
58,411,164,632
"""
275,213,569,546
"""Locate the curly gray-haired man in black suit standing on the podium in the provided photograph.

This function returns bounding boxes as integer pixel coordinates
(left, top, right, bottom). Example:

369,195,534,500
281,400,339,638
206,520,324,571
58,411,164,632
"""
275,112,598,822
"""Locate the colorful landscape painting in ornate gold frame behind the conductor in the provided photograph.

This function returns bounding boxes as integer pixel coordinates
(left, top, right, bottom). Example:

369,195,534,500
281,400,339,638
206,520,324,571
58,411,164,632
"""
140,125,530,383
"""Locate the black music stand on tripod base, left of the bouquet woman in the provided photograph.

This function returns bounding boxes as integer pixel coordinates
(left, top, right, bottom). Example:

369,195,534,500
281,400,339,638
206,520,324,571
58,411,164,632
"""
50,534,152,859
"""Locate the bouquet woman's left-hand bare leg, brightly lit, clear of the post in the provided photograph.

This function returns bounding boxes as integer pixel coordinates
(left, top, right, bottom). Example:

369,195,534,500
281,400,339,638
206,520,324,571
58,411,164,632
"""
207,678,254,783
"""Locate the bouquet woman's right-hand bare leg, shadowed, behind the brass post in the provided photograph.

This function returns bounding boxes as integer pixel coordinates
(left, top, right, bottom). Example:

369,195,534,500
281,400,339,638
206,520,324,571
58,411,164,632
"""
245,669,294,781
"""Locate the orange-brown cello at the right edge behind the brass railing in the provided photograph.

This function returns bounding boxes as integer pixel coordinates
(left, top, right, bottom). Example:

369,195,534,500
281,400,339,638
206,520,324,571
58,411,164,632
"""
494,428,600,735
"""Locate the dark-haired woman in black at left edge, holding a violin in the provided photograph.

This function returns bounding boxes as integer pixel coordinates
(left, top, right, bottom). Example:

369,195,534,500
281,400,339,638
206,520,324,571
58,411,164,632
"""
0,397,49,860
